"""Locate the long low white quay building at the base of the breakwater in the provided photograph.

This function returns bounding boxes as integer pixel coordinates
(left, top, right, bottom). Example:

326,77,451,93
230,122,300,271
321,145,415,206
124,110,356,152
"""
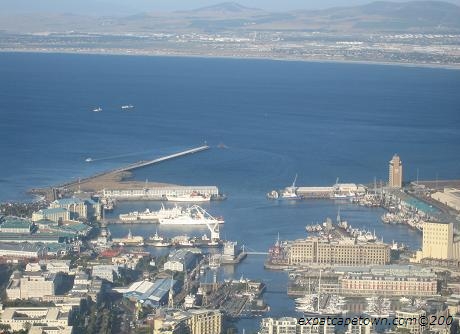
102,186,219,200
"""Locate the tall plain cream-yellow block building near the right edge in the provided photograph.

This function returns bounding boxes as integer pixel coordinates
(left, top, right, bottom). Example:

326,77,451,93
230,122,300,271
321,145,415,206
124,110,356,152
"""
422,222,454,260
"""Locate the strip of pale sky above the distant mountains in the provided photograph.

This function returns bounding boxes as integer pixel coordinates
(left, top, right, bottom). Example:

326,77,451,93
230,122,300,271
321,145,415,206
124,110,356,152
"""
0,0,460,15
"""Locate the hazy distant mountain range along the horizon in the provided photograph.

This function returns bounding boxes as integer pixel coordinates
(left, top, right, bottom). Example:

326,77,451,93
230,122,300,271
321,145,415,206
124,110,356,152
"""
0,1,460,33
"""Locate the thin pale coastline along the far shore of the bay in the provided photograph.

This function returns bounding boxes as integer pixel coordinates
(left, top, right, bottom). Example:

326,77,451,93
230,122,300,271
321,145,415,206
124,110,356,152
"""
0,49,460,71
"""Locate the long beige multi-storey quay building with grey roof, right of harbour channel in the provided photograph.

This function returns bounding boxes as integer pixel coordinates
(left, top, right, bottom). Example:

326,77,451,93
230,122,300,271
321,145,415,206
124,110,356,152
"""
286,237,390,266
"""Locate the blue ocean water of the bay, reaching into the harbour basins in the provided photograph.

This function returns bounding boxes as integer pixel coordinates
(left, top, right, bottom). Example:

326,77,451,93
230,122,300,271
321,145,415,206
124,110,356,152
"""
0,53,460,329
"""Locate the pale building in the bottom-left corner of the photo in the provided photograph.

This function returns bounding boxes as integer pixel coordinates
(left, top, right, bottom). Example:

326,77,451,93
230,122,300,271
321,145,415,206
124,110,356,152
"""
0,307,72,334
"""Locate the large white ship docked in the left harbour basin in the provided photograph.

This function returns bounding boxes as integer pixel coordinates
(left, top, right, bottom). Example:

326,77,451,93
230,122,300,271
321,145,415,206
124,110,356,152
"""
158,205,224,226
